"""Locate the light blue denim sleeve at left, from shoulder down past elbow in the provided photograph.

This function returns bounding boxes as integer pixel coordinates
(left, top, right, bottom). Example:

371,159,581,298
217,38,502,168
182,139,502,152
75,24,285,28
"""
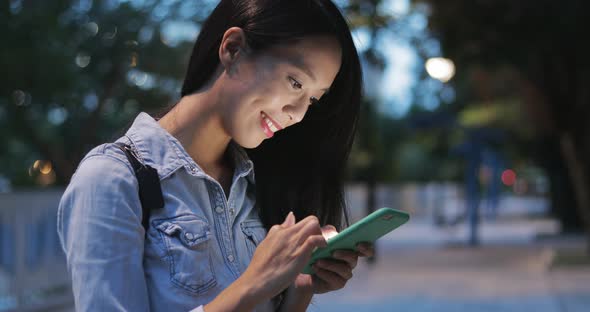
58,155,149,311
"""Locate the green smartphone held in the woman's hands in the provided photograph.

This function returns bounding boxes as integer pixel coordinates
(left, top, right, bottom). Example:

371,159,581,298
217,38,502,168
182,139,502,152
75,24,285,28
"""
302,208,410,274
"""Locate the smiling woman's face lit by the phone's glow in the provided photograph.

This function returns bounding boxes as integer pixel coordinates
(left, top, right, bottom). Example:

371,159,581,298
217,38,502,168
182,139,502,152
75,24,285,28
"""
221,36,341,148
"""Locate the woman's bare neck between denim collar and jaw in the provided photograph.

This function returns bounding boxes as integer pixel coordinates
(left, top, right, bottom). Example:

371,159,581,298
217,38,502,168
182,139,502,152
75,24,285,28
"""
158,88,231,172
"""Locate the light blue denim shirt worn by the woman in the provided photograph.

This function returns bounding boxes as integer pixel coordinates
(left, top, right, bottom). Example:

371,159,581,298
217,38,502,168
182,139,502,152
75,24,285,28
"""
58,113,274,311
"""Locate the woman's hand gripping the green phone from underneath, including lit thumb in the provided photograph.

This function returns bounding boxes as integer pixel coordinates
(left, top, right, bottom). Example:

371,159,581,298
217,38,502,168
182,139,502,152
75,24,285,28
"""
294,225,375,294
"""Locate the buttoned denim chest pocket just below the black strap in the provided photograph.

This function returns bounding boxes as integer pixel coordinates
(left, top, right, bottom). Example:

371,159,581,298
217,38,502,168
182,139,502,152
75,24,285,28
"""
152,214,217,295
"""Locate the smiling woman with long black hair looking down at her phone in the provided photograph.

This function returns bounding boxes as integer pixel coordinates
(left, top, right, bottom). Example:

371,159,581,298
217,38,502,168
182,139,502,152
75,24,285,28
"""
58,0,372,312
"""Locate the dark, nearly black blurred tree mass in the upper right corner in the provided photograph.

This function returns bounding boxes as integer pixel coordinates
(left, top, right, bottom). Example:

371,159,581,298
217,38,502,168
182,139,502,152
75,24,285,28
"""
421,0,590,250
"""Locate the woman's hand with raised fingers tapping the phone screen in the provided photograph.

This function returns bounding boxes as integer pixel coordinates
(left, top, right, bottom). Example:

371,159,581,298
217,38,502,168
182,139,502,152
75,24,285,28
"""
240,213,326,299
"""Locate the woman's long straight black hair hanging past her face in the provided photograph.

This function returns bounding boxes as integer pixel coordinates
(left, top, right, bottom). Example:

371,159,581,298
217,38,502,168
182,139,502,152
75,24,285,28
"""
181,0,362,229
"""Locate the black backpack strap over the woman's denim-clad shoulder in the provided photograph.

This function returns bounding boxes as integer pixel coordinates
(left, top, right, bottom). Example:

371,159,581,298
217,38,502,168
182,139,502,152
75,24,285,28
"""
115,142,164,233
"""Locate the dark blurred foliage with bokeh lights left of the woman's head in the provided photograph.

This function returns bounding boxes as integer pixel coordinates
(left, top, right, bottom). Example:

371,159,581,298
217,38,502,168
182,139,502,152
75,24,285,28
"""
0,0,215,186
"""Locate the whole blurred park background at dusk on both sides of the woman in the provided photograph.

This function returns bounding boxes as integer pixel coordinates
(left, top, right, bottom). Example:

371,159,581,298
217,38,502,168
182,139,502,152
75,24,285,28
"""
0,0,590,311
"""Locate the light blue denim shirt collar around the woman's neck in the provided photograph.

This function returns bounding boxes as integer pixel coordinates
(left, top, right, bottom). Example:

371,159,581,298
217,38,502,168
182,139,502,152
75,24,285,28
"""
125,112,254,183
